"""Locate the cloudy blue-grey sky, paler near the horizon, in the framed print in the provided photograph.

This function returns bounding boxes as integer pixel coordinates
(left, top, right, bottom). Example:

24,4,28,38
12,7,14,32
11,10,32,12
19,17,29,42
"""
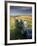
10,6,32,16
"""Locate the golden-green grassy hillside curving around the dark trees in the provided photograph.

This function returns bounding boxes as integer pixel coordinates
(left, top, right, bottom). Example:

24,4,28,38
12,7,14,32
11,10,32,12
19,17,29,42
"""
10,15,32,31
